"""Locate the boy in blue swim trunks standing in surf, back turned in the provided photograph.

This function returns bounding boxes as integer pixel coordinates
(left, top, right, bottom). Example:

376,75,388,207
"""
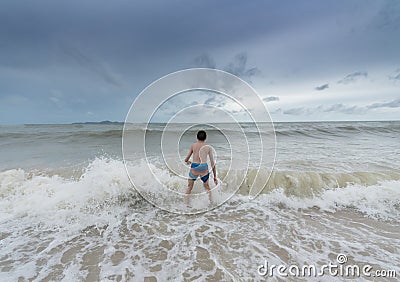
185,130,218,203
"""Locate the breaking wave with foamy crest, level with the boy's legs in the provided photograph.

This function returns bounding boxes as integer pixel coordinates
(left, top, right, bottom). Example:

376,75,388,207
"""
0,158,400,224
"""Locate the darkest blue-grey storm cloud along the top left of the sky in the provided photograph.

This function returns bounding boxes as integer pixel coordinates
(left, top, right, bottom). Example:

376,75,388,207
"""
0,0,300,65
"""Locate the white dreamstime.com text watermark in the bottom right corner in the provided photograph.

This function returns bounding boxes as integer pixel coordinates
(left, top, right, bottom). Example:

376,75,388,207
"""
257,254,397,278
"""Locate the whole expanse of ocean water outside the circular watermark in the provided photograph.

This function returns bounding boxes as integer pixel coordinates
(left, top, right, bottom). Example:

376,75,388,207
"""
0,121,400,281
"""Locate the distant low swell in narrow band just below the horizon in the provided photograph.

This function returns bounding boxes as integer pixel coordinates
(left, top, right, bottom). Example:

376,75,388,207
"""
0,121,400,139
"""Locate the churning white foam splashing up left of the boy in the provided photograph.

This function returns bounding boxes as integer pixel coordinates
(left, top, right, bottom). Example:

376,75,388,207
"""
0,158,133,230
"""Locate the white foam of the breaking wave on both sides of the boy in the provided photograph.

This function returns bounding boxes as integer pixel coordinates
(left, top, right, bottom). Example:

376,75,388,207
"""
0,158,400,225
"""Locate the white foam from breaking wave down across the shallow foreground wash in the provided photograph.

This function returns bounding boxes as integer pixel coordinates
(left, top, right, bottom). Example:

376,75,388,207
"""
0,158,400,281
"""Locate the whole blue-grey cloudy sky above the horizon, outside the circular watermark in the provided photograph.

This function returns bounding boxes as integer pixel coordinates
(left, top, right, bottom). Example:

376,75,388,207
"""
0,0,400,124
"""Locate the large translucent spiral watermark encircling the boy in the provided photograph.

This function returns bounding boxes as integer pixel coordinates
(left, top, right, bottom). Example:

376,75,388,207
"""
122,68,275,214
